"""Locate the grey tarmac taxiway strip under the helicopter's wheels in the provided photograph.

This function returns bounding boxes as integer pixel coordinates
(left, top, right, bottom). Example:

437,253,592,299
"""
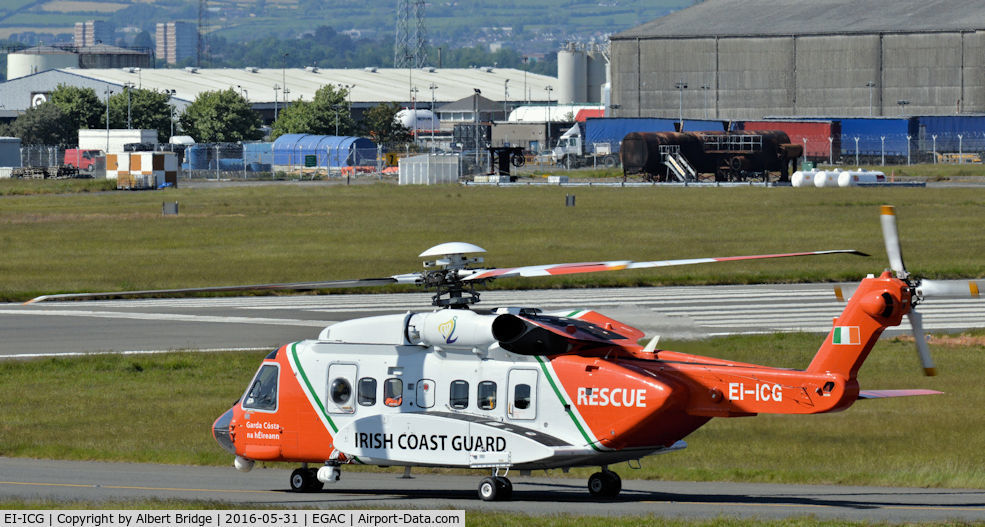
0,458,985,522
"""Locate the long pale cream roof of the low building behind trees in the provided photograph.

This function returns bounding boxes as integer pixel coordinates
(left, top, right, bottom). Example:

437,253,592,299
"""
60,68,558,104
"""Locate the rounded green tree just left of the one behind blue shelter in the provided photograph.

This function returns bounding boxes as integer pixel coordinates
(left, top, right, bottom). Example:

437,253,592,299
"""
180,88,263,143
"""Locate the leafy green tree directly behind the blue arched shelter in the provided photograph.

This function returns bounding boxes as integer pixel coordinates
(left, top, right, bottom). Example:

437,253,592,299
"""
270,84,356,138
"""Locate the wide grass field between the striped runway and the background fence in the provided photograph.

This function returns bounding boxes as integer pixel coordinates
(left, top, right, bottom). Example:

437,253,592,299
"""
0,182,985,300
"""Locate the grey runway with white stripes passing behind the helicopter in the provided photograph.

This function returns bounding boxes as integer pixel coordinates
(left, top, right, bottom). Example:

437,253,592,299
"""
0,284,985,357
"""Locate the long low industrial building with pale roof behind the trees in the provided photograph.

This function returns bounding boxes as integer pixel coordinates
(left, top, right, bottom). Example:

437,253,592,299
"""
0,64,558,122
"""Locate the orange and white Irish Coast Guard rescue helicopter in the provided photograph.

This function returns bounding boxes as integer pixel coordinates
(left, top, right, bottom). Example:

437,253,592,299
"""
26,207,977,501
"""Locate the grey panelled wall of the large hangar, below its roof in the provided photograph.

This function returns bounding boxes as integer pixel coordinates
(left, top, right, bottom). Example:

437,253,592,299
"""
612,31,985,119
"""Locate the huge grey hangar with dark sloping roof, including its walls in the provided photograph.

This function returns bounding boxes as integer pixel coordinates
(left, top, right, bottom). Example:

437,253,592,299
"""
611,0,985,119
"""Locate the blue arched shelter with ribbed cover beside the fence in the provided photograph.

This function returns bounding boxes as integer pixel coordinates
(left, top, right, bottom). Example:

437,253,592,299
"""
273,134,377,168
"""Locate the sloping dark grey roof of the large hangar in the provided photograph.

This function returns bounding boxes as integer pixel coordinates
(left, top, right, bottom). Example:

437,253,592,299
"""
611,0,985,40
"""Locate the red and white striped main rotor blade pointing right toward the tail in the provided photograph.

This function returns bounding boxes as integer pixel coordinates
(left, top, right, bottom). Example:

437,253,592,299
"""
459,249,869,281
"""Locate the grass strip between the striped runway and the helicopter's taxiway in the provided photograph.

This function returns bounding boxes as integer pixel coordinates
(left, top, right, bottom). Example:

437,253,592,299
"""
0,334,985,488
